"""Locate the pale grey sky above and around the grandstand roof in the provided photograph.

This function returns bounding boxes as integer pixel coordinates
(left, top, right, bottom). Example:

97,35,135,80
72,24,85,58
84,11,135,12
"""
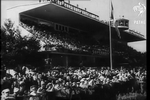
1,0,147,52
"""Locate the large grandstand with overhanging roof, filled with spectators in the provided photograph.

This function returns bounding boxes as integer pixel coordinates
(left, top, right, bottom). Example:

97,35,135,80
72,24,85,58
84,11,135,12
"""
6,0,145,66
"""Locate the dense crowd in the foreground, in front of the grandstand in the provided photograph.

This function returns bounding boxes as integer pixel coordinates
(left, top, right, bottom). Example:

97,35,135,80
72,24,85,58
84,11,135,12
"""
1,66,147,100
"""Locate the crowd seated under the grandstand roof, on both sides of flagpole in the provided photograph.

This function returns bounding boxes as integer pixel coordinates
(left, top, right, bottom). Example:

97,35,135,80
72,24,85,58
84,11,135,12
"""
20,19,139,56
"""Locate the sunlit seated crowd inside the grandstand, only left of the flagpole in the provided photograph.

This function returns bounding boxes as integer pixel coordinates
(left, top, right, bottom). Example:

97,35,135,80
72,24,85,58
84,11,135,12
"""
20,20,113,55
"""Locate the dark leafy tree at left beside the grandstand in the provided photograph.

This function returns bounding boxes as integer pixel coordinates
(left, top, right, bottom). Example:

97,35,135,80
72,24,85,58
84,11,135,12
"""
1,19,40,68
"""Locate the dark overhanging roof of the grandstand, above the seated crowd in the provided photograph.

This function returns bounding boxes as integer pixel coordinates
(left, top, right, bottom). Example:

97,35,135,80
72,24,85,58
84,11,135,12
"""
20,3,145,42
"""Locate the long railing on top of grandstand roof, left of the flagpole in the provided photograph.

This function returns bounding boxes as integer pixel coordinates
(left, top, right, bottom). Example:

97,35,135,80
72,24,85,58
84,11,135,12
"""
51,0,99,20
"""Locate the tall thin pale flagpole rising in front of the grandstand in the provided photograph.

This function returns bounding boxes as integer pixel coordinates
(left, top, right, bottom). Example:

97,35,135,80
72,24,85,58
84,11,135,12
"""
109,0,113,70
